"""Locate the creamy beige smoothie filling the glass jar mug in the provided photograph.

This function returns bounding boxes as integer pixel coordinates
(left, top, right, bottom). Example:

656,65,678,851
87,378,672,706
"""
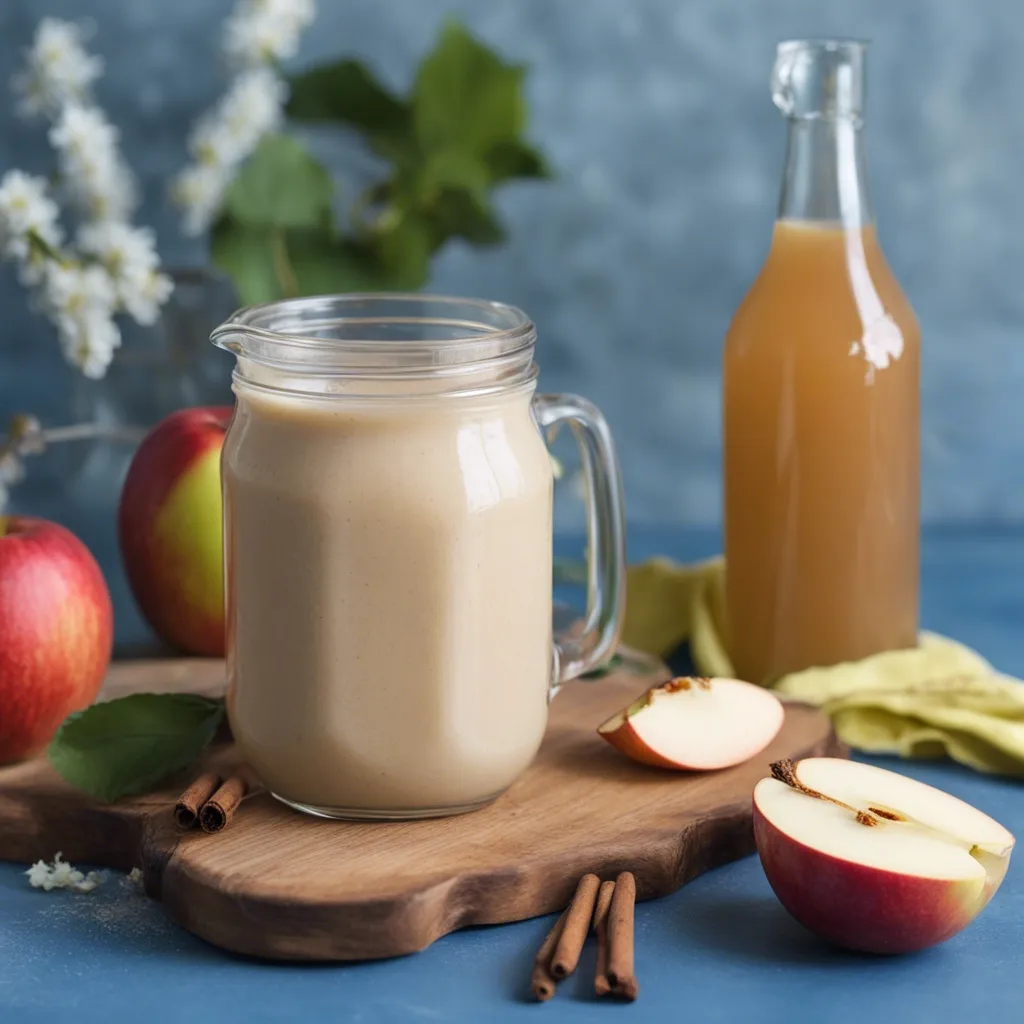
223,381,552,816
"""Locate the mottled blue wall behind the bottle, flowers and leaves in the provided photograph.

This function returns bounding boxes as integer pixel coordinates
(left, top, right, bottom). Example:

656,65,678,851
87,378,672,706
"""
0,0,1024,523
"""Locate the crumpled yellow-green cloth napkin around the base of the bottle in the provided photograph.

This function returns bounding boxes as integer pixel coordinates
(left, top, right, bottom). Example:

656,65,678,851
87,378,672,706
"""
623,558,1024,775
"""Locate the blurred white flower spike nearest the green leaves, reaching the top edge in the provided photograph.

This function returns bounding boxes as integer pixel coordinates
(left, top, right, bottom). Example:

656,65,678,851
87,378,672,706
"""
172,0,316,236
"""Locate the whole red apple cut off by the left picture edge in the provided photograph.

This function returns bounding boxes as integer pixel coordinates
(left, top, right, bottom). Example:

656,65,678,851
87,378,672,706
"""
0,516,114,765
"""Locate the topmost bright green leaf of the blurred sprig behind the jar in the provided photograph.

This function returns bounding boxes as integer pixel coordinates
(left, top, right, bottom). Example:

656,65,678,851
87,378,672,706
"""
413,22,525,156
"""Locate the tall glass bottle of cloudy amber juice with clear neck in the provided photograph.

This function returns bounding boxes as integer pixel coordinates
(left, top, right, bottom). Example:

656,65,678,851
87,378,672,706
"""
723,40,920,681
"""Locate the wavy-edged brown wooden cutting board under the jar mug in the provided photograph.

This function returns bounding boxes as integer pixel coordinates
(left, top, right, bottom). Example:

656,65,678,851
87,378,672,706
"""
0,658,844,961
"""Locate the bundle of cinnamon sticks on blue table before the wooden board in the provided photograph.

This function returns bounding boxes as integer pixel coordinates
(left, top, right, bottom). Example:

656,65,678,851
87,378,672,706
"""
530,871,639,1002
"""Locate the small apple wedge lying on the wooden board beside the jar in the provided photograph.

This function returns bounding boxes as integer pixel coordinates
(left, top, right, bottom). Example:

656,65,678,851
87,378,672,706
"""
597,676,784,771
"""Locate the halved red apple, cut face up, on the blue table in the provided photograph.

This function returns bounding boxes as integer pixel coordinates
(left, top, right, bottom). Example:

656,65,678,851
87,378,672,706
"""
754,758,1014,953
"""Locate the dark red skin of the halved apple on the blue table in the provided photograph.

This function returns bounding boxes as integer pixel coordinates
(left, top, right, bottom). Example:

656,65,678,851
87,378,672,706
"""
754,802,997,953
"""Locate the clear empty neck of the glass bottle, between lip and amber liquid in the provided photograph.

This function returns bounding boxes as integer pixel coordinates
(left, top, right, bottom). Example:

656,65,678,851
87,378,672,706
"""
778,118,874,228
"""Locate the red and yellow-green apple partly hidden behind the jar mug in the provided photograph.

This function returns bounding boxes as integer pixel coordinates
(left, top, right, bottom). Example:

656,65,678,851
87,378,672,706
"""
118,407,232,656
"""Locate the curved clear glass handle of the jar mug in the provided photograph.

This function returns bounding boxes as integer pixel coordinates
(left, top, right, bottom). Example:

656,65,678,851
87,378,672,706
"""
534,394,626,696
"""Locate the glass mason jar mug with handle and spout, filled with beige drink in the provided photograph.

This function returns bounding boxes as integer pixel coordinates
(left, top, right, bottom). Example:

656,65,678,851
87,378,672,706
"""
213,295,625,819
